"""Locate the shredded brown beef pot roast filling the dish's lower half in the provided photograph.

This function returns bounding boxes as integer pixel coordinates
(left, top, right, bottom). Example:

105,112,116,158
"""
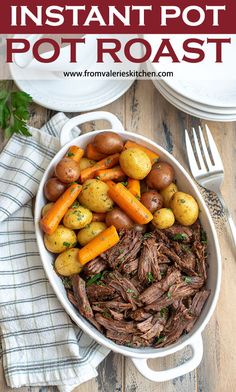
68,222,210,347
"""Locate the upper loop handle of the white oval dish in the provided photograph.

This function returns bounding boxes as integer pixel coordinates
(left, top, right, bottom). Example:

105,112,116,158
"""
60,112,124,147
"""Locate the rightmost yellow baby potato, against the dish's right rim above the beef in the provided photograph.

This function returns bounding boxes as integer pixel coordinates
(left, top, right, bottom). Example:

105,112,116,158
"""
170,192,199,226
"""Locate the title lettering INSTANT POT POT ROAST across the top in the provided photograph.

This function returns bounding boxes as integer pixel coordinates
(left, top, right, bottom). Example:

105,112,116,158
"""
6,0,231,63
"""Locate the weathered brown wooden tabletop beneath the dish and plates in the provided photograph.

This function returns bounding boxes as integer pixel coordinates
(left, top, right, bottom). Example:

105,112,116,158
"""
0,81,236,392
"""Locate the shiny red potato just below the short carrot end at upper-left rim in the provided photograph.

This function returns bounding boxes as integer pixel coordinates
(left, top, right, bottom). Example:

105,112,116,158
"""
55,158,80,184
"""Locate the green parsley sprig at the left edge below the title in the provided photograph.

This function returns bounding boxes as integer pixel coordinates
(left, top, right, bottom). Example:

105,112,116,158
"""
0,89,32,138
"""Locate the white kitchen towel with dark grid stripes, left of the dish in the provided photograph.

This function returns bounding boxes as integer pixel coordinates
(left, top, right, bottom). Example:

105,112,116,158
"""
0,113,108,391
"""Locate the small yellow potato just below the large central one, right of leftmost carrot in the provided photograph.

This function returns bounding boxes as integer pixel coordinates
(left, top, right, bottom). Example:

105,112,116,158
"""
63,204,93,230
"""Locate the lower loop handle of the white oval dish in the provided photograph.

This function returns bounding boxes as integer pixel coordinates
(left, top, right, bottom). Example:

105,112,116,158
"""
131,335,203,382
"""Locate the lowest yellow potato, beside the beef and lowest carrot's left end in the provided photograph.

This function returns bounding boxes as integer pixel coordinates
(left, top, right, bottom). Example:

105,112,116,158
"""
55,248,82,276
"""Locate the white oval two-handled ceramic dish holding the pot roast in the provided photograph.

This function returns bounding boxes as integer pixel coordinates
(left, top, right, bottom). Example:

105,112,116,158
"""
35,112,221,382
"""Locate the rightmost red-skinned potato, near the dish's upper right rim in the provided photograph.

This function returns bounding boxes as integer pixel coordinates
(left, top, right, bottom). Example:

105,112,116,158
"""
146,162,175,190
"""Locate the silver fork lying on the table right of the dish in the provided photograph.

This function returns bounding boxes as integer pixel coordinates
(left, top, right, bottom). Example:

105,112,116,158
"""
185,125,236,246
